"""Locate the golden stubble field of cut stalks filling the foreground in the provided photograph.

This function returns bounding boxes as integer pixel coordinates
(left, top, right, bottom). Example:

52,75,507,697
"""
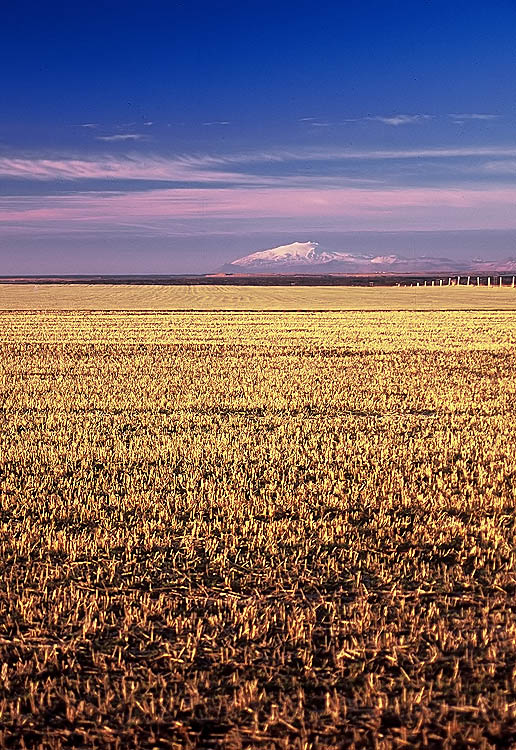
0,306,516,750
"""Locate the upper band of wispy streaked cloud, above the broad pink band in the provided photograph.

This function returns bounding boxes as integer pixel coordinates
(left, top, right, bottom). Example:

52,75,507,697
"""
0,146,516,187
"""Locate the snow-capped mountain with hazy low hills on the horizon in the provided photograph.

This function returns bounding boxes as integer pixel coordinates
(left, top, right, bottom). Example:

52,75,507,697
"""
221,242,516,275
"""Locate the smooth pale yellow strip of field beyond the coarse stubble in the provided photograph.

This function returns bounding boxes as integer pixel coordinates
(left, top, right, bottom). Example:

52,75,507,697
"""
0,284,516,311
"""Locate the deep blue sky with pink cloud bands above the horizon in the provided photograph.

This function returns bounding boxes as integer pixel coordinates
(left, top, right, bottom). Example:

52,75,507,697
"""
0,0,516,275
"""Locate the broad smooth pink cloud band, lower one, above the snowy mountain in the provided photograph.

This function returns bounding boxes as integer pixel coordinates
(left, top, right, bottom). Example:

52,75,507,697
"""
0,187,516,229
